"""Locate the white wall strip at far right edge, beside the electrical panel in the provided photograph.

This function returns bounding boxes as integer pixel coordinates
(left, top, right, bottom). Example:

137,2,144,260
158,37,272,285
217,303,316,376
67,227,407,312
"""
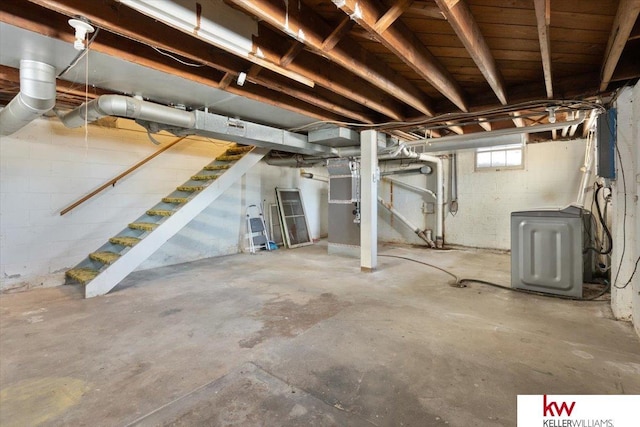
611,84,640,334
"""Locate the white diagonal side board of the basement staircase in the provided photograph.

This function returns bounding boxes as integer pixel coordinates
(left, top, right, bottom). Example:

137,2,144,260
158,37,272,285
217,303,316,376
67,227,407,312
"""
84,147,269,298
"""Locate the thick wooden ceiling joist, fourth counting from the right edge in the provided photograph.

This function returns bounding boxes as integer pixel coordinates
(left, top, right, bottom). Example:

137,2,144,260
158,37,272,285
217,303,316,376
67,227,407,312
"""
337,0,468,115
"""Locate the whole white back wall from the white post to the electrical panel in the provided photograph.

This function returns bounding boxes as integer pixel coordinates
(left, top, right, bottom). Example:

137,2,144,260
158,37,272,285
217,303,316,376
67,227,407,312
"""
379,140,591,249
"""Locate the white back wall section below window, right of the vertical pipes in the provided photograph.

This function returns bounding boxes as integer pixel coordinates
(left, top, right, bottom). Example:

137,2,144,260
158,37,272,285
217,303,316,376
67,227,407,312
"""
445,139,591,249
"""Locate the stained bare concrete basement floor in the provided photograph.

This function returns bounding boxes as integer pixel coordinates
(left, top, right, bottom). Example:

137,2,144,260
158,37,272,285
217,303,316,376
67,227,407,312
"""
0,244,640,426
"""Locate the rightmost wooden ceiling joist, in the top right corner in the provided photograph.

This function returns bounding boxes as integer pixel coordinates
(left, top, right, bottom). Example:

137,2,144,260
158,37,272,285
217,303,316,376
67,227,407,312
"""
600,0,640,91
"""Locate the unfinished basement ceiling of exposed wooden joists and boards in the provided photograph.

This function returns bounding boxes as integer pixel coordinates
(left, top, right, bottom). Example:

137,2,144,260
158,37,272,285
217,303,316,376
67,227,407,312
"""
0,0,640,139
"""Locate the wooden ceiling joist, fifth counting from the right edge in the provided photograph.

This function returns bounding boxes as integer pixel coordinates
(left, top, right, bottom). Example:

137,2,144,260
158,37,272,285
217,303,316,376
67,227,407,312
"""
228,0,434,115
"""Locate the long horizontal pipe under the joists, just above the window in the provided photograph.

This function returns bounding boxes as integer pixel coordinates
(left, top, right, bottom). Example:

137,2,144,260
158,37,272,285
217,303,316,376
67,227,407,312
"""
406,113,584,153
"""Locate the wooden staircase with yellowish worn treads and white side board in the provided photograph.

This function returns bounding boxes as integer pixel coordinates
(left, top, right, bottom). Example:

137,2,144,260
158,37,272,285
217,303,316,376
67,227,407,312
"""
66,146,269,298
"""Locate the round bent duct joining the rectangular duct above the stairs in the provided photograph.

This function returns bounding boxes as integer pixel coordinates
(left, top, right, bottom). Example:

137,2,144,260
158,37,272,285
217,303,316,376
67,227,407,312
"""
60,95,196,129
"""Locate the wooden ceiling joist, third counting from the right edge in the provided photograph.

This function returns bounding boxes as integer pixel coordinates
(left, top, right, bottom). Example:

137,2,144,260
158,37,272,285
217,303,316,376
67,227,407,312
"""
435,0,507,105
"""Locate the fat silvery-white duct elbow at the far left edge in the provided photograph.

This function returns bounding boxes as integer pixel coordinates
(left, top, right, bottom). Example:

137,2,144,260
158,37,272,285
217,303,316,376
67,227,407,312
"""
0,59,56,136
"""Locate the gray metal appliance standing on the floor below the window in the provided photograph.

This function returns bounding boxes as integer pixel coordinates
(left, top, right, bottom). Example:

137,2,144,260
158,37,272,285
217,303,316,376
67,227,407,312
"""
511,206,593,297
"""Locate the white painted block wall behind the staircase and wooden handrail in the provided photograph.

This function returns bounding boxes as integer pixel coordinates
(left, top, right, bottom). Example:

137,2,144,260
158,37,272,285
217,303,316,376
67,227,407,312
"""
0,119,326,290
